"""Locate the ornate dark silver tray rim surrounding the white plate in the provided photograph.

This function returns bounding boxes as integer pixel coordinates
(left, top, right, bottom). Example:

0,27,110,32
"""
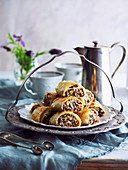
6,105,126,135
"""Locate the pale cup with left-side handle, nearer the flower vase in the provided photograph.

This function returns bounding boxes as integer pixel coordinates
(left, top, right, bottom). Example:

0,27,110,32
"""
25,71,64,99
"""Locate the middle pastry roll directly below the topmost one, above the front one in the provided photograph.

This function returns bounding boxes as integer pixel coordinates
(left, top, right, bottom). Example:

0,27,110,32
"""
51,96,84,112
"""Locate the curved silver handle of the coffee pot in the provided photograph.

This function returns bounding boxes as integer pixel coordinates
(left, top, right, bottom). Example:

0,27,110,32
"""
111,42,127,79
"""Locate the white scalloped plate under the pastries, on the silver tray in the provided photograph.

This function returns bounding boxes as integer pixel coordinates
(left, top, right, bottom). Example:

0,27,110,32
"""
18,103,116,130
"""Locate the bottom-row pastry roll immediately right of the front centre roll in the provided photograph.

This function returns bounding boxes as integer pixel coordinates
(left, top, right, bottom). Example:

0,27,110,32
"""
77,108,99,126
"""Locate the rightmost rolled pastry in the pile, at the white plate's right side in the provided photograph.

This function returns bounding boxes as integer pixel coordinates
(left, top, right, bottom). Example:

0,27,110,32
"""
89,99,105,117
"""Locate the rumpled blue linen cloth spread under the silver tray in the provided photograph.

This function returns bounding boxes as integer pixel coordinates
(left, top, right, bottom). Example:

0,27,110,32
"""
0,79,128,170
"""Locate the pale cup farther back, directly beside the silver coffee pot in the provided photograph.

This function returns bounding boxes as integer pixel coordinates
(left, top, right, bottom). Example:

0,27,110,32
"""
55,63,83,84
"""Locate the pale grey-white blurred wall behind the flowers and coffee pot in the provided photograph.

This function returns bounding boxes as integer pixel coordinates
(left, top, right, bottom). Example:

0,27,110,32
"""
0,0,128,84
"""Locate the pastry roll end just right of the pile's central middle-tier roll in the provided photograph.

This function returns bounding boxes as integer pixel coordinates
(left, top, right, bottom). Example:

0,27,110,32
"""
80,89,94,107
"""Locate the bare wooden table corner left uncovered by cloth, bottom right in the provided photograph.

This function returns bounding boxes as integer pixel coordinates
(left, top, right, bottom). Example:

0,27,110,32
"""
77,138,128,170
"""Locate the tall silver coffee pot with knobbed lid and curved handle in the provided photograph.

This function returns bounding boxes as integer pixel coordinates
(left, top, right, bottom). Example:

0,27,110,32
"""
74,41,127,105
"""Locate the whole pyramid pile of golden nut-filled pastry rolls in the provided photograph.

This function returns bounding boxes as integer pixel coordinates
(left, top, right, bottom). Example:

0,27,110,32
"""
30,80,105,127
